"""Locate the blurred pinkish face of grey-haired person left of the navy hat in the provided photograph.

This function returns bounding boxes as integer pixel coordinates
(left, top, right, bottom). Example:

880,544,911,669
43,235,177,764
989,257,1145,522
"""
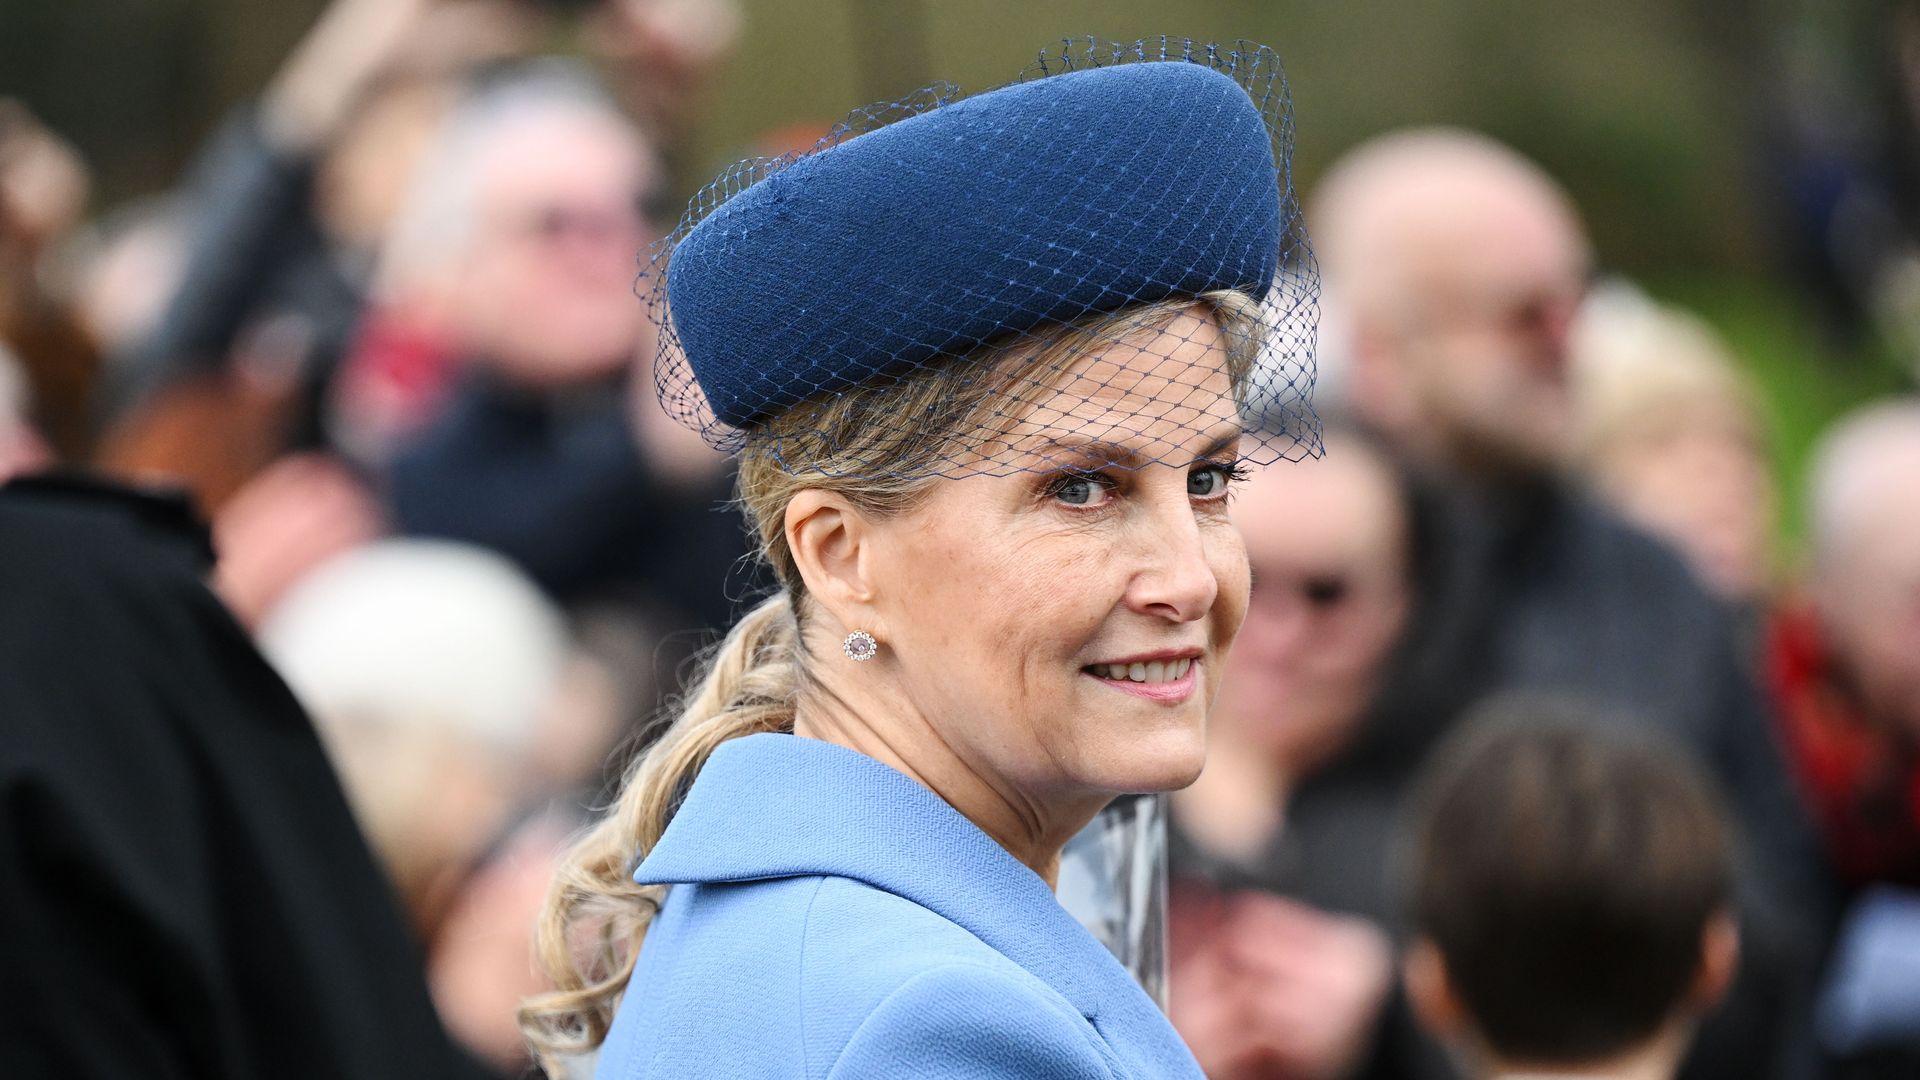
455,117,653,386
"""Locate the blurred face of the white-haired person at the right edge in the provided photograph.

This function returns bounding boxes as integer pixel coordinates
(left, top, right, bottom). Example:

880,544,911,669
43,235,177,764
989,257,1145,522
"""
1818,490,1920,740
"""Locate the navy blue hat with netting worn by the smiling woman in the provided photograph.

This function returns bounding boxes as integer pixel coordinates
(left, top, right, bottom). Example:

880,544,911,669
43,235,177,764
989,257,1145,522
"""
651,42,1317,470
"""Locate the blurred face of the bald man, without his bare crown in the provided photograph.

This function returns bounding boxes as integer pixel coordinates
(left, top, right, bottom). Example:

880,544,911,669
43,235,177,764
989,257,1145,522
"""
1386,181,1588,471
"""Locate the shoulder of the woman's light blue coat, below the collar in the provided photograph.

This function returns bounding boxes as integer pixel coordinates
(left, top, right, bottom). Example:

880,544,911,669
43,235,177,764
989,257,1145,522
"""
601,876,1112,1080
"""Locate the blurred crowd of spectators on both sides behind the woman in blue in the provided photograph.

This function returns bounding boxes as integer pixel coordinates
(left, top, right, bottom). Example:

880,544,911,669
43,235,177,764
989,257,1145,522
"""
0,0,1920,1078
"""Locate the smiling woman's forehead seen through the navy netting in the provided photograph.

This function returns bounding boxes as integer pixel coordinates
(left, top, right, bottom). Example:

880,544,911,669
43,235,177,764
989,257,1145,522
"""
1002,307,1240,467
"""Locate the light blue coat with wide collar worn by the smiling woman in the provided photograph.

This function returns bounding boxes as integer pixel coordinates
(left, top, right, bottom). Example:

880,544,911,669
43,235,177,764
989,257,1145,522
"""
595,734,1200,1080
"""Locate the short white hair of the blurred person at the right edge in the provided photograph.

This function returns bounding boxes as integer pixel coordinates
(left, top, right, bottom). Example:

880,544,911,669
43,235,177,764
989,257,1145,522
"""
1809,398,1920,563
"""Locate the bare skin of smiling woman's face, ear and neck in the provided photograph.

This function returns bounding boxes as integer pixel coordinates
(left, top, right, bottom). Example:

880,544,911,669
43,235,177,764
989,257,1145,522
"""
785,311,1248,886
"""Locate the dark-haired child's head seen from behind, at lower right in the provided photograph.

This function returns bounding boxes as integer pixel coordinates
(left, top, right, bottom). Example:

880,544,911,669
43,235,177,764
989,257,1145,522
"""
1405,698,1740,1080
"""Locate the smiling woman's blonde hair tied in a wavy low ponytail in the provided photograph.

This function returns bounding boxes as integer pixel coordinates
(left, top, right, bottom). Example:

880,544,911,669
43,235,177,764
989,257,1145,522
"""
520,292,1261,1076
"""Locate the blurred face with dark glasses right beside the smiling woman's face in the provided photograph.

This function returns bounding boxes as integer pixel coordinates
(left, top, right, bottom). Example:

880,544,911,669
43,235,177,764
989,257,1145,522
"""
1215,442,1409,776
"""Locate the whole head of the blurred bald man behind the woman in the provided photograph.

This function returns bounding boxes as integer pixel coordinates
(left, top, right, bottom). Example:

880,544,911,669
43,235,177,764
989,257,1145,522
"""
1313,131,1592,477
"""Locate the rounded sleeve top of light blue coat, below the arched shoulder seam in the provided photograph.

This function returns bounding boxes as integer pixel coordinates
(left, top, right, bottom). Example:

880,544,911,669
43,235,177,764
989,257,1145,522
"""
828,961,1116,1080
